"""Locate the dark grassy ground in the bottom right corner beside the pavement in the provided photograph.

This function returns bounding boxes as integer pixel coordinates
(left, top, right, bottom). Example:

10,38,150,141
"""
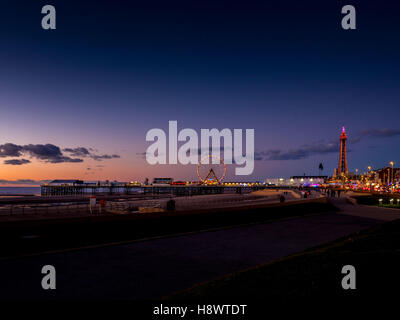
166,220,400,303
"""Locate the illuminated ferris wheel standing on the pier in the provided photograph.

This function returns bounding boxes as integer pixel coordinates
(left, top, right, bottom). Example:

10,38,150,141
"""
197,155,226,184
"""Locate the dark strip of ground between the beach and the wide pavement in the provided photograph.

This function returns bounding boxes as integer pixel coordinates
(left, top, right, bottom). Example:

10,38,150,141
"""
0,199,335,259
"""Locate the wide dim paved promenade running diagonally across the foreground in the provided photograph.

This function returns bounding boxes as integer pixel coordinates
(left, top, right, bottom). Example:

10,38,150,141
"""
0,199,384,300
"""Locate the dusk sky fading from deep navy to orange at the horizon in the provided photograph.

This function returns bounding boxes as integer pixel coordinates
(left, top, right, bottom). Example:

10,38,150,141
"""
0,0,400,184
